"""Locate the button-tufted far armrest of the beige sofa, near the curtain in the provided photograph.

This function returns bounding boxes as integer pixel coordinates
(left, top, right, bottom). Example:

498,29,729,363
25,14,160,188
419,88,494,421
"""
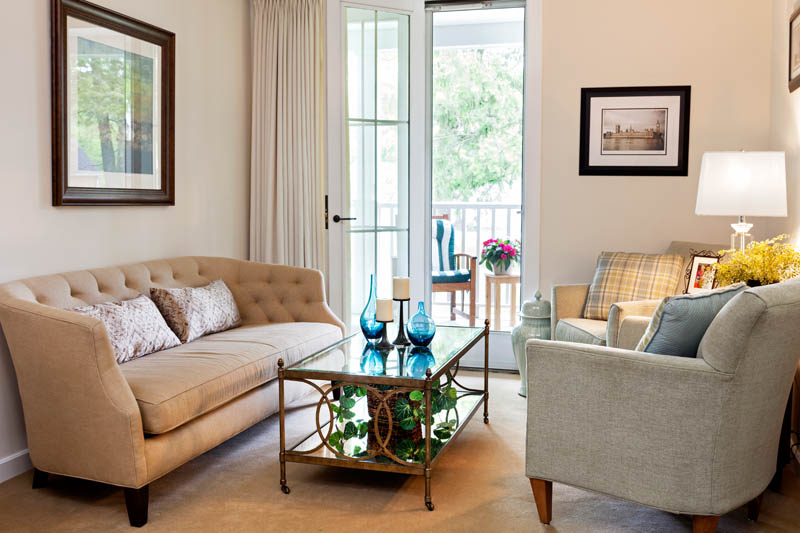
234,261,345,335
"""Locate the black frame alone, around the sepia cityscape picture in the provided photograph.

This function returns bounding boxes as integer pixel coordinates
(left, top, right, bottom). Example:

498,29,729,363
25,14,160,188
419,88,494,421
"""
578,85,692,176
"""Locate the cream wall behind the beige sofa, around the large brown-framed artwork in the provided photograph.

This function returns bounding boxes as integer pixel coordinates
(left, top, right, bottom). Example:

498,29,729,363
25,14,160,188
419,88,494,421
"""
0,0,250,481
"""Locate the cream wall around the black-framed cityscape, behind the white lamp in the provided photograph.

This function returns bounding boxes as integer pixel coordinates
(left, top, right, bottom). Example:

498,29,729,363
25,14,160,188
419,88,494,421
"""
540,0,772,294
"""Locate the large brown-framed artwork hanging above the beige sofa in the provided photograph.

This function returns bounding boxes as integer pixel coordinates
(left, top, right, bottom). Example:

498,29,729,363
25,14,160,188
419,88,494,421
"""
51,0,175,206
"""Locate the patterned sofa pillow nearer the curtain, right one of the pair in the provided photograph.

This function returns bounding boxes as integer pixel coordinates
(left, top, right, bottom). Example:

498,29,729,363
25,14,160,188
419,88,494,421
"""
150,279,242,342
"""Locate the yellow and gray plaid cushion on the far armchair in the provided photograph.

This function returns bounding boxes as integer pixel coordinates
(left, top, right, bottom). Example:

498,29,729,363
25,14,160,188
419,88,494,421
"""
583,252,683,320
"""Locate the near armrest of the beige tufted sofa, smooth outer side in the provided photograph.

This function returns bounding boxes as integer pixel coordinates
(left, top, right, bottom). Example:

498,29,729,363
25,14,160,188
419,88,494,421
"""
0,298,147,487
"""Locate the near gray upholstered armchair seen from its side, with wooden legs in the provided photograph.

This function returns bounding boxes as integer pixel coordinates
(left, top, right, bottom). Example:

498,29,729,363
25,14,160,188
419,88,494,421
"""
526,280,800,531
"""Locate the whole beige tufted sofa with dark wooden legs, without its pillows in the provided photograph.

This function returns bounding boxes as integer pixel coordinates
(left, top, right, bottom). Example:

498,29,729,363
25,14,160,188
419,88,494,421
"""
0,257,344,525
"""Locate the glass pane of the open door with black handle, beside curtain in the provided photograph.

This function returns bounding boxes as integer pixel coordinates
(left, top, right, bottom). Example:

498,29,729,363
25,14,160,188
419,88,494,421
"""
344,7,409,328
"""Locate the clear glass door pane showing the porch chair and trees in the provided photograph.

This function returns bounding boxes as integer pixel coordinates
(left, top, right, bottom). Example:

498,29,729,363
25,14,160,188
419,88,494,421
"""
431,8,525,330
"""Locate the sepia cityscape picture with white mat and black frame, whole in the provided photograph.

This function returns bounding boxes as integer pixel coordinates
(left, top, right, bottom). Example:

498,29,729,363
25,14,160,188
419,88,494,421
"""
578,86,691,176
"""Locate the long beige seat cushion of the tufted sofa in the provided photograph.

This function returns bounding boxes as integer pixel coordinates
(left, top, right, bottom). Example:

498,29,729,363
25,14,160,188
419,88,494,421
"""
119,322,342,434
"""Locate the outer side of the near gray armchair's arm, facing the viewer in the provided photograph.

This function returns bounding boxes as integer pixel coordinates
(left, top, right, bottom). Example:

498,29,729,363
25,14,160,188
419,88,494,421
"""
526,340,733,514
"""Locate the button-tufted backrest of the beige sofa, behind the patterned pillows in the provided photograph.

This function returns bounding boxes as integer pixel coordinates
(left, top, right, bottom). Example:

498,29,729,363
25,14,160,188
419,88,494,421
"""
0,257,329,324
